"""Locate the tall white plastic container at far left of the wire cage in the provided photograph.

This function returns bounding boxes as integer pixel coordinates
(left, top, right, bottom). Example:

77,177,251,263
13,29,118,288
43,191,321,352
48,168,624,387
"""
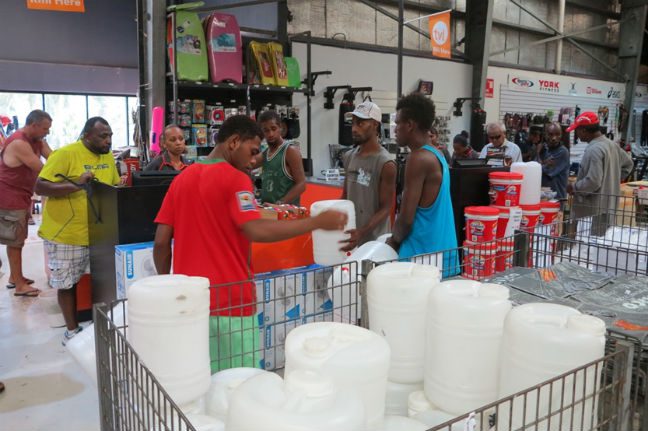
128,275,211,405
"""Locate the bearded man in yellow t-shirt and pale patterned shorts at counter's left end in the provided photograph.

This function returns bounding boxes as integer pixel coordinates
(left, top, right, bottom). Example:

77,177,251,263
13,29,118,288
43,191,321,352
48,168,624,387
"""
36,117,120,345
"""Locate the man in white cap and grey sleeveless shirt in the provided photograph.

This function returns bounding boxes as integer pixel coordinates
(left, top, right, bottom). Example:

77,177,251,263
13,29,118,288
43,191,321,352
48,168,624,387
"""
341,102,396,251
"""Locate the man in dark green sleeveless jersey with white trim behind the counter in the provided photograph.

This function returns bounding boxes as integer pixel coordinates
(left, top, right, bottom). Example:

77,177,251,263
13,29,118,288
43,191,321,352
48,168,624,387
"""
257,111,306,205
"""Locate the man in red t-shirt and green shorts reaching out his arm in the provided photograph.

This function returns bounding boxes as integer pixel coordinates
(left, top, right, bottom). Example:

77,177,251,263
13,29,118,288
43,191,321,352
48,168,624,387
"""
153,115,347,372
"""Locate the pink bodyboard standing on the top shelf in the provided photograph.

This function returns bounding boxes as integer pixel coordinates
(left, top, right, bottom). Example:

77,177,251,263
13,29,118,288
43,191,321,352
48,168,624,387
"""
205,12,243,84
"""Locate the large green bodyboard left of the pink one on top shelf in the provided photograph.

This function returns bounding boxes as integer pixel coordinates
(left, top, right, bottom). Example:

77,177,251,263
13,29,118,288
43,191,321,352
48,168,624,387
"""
167,10,209,81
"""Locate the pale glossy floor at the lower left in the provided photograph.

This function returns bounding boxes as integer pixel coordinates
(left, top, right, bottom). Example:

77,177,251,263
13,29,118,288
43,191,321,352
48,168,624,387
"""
0,218,99,431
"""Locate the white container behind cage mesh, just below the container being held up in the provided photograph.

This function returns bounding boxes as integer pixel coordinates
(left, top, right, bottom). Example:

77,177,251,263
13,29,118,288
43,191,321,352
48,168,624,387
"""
327,241,398,324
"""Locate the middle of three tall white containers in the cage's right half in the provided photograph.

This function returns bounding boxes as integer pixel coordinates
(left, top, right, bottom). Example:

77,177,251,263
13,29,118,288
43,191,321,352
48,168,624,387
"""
424,280,511,415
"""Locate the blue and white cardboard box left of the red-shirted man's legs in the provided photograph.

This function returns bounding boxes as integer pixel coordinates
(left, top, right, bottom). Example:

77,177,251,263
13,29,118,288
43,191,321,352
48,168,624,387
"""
115,241,157,299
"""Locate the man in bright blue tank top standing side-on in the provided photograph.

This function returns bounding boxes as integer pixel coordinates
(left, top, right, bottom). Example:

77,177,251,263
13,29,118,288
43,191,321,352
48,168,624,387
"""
387,93,459,277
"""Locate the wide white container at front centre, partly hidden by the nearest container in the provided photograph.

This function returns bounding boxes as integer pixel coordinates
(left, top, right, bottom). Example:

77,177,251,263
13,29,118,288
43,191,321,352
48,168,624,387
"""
284,322,390,429
